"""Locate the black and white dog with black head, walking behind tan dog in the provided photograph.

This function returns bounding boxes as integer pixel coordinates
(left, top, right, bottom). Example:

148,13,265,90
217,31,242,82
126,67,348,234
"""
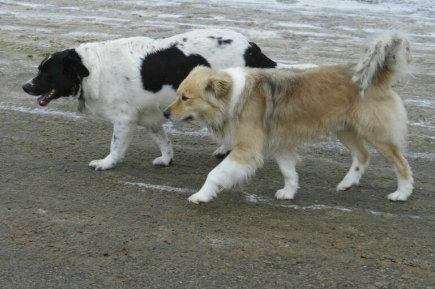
23,29,315,170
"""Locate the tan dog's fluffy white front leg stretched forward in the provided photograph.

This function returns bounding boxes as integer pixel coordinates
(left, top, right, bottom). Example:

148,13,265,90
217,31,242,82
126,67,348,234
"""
188,149,261,204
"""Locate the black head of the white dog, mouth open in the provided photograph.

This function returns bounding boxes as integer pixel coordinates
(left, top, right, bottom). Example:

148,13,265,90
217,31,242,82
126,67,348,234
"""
23,49,89,106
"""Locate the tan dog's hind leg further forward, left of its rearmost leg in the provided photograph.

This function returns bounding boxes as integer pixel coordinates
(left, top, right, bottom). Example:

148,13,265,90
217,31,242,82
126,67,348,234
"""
336,129,370,191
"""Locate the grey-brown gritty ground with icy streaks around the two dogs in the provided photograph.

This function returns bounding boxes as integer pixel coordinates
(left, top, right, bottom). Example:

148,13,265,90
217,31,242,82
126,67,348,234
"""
0,0,435,289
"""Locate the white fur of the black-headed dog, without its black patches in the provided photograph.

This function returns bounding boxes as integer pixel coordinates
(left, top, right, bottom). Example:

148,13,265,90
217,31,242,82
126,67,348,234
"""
74,29,316,170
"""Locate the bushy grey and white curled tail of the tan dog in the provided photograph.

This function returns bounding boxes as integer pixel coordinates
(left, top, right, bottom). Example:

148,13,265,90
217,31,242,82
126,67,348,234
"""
352,33,412,97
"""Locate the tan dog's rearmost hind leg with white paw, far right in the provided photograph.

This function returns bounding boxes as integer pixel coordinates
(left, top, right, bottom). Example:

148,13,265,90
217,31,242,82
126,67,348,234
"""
367,139,414,201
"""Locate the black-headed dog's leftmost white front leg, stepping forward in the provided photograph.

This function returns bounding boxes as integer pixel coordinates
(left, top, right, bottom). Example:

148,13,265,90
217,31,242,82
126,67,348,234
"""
89,122,136,171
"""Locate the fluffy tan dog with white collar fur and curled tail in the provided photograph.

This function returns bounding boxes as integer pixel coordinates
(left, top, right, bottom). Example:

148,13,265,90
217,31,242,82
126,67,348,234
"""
164,33,413,204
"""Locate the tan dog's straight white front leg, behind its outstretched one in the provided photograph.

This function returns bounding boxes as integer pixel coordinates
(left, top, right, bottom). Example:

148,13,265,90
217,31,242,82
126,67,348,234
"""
275,151,299,200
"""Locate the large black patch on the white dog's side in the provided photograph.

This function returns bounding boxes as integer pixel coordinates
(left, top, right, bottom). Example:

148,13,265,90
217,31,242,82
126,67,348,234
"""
140,46,210,92
